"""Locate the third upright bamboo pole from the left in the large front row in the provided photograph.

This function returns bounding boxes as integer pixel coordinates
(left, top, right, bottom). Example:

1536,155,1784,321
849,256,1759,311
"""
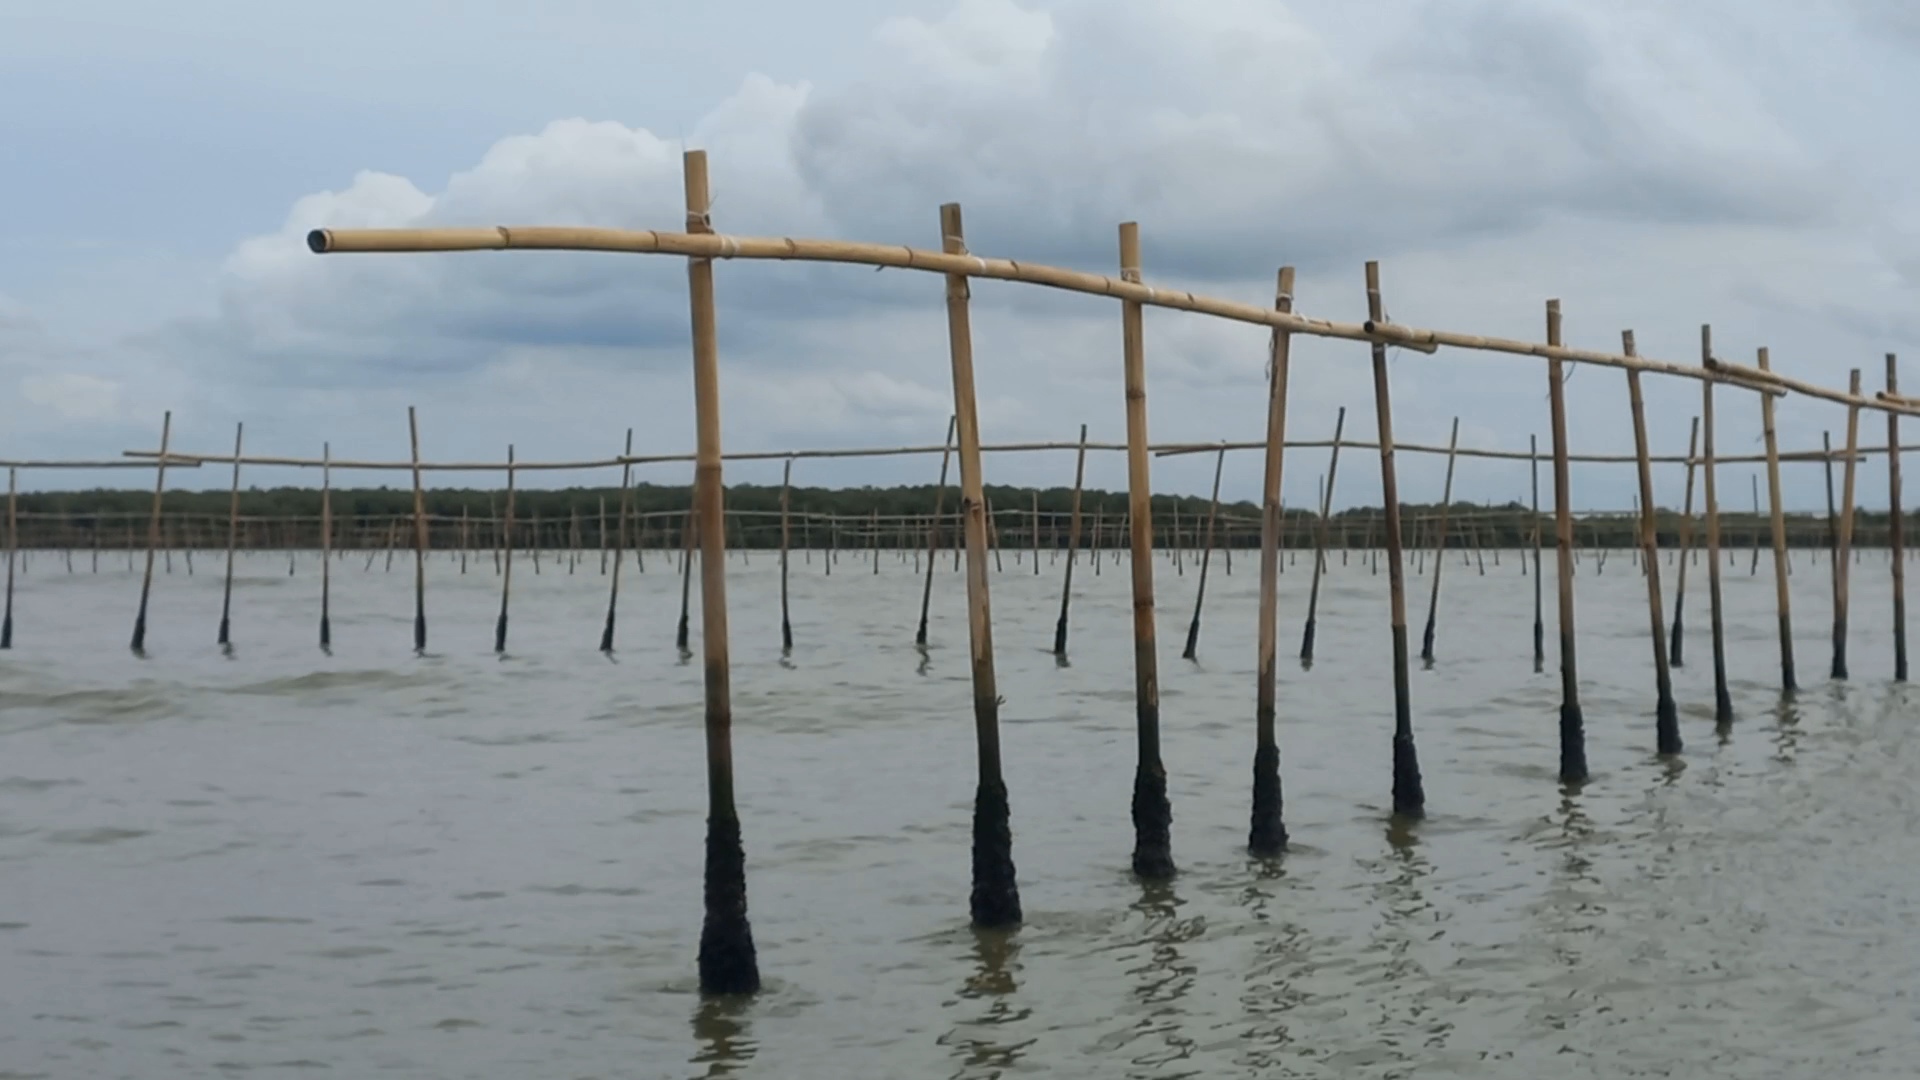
1119,221,1173,880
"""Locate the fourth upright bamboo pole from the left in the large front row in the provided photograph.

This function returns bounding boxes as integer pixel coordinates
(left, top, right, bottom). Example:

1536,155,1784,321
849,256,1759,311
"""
1246,267,1297,859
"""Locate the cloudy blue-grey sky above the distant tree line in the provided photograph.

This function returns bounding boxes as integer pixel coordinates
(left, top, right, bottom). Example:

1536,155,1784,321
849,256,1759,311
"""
0,0,1920,509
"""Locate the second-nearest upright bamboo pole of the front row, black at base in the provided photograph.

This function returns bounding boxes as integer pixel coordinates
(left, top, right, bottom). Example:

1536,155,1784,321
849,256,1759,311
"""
941,202,1020,928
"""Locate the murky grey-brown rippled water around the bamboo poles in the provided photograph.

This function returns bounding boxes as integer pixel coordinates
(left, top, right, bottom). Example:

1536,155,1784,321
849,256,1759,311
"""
0,552,1920,1078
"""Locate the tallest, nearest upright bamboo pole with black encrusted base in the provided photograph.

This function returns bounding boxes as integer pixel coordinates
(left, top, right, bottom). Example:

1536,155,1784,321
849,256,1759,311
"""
685,150,760,994
